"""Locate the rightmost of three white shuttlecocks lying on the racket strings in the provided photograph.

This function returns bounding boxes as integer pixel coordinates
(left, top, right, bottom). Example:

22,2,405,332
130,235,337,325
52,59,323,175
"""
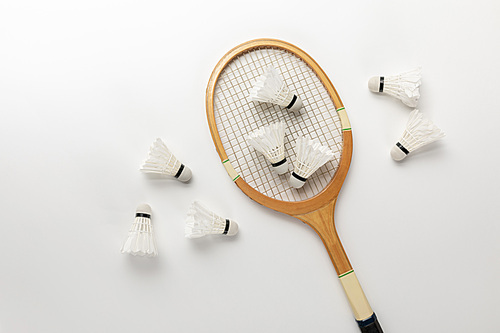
289,136,334,188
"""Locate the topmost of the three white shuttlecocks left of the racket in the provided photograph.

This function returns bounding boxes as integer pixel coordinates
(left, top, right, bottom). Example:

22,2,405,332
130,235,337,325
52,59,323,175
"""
141,139,192,182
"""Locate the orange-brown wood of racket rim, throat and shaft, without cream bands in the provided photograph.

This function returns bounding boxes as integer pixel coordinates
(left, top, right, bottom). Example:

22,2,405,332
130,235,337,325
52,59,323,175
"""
206,39,352,275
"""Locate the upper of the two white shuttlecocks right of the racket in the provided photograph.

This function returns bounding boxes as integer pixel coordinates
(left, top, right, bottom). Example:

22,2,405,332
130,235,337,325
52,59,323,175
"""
368,67,422,107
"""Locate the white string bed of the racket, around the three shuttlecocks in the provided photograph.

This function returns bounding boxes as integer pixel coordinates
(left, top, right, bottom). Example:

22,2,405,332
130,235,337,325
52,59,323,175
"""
214,48,342,201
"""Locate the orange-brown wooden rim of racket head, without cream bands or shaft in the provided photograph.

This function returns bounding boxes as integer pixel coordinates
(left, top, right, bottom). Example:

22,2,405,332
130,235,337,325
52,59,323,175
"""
206,38,352,216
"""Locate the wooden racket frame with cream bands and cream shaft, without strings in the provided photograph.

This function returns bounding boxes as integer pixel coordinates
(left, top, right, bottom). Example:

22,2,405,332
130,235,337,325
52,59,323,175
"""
206,39,376,326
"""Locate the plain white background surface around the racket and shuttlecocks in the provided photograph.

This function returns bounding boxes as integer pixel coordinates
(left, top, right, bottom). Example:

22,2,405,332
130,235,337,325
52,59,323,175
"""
0,0,500,333
